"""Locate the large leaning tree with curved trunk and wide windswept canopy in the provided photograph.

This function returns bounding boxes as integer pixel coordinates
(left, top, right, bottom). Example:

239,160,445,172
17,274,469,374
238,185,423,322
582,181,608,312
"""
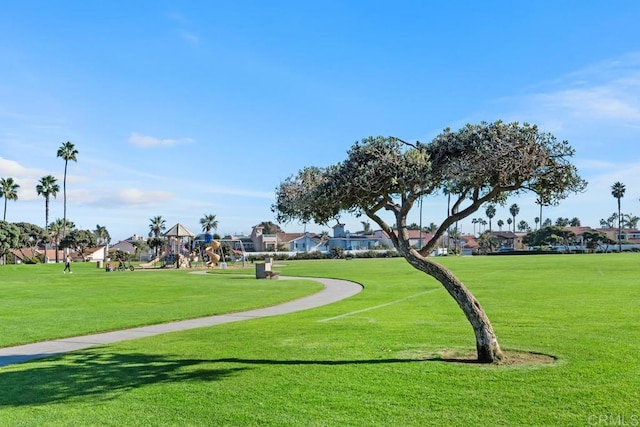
272,121,586,363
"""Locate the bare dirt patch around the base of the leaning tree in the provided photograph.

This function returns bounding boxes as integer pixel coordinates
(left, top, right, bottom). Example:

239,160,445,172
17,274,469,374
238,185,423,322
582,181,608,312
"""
401,349,558,366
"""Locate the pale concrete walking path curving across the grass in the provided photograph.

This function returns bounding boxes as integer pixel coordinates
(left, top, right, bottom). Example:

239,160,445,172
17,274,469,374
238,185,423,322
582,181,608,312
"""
0,276,362,367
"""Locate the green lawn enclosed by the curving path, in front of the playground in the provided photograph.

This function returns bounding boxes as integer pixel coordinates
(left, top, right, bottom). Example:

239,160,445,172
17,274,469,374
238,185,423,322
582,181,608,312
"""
0,263,322,347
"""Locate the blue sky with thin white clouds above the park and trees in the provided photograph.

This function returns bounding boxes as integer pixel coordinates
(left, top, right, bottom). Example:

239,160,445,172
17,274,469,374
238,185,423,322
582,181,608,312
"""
0,0,640,241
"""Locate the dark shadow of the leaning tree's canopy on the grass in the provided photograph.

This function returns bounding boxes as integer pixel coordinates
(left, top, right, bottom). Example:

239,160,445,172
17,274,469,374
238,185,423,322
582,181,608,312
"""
0,351,247,408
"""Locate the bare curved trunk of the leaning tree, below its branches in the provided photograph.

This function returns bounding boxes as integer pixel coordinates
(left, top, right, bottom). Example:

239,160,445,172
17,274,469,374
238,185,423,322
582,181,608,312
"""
404,249,504,363
